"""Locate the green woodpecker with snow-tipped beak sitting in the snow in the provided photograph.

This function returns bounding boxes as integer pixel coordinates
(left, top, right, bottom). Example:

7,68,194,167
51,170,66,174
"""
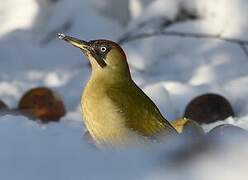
58,33,178,148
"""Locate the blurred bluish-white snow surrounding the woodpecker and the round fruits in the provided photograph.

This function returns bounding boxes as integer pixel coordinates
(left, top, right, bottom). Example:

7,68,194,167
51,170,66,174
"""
0,0,248,180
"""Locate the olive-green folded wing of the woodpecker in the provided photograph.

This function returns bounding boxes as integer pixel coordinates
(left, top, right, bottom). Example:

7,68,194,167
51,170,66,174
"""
107,83,176,137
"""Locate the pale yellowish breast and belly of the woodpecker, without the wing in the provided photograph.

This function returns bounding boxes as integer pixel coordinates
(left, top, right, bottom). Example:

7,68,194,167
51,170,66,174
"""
81,85,139,146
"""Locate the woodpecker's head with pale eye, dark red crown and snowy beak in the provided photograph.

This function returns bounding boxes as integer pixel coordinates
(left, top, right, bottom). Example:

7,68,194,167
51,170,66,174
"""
58,33,130,80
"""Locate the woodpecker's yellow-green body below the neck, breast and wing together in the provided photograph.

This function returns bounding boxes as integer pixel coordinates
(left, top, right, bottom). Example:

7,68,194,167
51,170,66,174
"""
82,72,177,146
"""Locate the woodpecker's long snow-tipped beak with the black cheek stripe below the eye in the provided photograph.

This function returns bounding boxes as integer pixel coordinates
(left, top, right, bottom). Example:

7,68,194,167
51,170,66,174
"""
58,33,107,68
